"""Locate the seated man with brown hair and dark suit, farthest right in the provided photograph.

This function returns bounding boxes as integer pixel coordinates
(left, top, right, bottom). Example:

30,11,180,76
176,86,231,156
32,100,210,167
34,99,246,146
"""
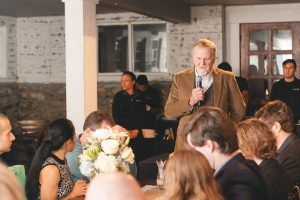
255,100,300,185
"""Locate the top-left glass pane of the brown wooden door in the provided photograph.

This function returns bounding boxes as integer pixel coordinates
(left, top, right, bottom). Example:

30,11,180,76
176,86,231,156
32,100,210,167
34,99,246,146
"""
249,30,269,51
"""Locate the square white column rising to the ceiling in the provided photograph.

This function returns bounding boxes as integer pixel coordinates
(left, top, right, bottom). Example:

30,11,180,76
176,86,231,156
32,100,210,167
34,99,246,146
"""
62,0,98,134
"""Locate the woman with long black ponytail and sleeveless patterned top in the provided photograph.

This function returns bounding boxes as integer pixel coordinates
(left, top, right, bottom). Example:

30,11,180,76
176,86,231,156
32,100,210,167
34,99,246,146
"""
26,119,87,200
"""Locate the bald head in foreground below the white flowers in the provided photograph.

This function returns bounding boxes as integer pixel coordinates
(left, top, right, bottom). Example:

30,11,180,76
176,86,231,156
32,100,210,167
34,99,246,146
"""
86,173,145,200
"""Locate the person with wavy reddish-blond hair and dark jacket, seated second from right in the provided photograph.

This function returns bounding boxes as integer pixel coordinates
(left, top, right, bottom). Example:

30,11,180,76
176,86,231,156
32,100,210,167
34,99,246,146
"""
237,118,291,200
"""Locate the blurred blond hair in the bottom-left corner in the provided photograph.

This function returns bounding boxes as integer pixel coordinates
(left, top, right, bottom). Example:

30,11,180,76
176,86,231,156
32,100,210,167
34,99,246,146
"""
0,163,25,200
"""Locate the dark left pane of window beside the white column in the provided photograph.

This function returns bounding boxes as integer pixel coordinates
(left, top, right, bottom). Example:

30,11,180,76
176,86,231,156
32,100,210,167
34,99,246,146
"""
98,25,128,73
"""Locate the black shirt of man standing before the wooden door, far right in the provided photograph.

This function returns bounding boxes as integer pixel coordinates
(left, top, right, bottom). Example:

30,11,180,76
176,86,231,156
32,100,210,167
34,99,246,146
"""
271,78,300,122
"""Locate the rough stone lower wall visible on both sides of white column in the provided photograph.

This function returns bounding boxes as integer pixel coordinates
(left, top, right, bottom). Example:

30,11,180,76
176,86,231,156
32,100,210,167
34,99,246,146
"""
0,82,171,121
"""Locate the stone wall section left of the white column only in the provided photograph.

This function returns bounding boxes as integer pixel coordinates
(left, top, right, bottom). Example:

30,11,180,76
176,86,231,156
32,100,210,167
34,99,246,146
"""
0,83,66,121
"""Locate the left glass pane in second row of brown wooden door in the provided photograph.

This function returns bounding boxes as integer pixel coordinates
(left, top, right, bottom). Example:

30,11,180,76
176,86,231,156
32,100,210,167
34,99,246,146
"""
248,55,268,77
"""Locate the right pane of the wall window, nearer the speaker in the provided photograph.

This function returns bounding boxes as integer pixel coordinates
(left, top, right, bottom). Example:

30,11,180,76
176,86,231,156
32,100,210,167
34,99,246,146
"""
133,24,167,72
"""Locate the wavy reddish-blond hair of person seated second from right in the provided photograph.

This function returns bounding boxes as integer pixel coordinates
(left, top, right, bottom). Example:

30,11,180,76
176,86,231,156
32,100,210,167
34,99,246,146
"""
237,118,277,160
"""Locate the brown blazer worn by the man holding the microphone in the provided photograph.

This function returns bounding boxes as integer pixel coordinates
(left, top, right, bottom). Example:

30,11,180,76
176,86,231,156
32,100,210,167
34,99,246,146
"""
165,67,246,151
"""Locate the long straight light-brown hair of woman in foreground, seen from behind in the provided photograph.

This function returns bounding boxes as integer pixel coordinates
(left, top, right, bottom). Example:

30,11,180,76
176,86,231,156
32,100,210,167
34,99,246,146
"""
165,150,223,200
